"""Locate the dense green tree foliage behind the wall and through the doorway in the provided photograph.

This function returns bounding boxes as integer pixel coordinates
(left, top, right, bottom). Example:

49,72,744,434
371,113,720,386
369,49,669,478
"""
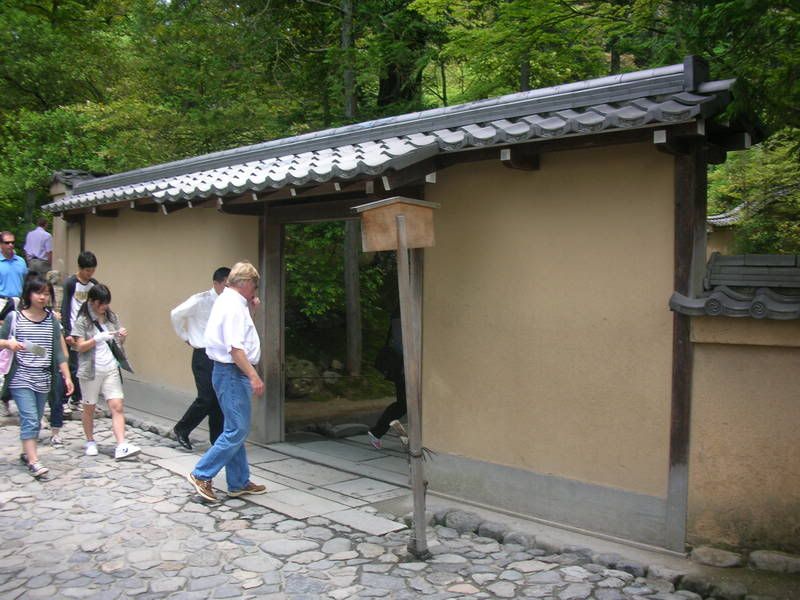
0,0,800,366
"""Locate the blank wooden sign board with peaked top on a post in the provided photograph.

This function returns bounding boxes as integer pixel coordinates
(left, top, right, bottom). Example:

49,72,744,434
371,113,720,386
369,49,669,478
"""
353,196,439,252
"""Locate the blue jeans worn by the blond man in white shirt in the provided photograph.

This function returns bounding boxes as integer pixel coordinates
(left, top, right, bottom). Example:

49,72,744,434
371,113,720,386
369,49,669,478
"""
192,361,253,491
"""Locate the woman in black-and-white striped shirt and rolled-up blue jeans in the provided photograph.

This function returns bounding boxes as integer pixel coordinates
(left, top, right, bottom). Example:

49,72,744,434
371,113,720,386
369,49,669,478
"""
0,276,72,478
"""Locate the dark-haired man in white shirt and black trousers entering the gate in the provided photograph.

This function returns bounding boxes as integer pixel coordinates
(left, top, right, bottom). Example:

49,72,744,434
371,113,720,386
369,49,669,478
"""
170,267,231,450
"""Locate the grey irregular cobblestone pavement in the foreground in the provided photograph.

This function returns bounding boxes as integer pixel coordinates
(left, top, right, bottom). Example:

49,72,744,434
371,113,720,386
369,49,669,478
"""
0,419,788,600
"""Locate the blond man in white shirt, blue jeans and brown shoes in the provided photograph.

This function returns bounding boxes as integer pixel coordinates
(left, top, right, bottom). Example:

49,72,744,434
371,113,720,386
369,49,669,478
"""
187,262,266,502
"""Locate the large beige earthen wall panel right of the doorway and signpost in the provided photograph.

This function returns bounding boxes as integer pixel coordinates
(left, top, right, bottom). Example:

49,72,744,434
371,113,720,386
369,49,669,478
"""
423,144,674,497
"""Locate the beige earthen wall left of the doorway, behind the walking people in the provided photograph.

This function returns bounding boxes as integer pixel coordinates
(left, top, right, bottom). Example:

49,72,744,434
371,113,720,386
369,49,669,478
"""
52,208,258,392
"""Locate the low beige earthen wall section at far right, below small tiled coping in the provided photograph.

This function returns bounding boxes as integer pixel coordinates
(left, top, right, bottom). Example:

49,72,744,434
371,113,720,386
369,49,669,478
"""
688,317,800,552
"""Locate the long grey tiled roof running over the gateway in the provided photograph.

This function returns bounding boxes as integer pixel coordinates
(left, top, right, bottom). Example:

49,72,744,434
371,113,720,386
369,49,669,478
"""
46,60,733,213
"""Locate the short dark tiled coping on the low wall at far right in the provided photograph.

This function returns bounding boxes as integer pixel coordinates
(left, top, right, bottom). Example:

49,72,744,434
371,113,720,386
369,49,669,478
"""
669,252,800,320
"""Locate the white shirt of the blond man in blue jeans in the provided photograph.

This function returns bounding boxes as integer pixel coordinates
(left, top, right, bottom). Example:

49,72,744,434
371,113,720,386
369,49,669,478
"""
205,288,261,365
